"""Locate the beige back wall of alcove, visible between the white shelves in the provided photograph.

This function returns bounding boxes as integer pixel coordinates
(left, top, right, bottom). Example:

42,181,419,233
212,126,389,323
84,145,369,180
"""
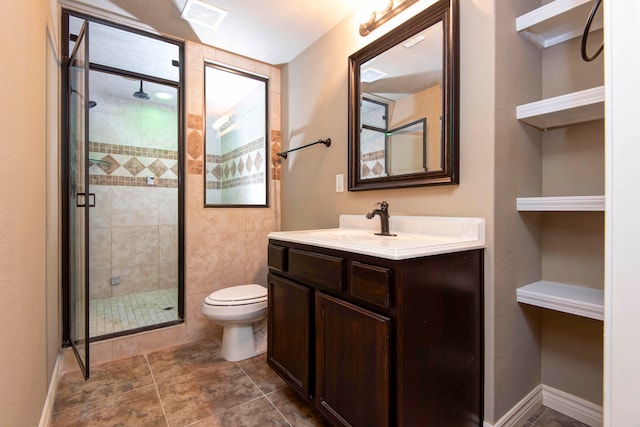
541,25,605,405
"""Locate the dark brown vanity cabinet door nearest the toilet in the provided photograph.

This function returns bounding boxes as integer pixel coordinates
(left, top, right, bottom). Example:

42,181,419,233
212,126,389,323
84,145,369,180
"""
267,274,312,399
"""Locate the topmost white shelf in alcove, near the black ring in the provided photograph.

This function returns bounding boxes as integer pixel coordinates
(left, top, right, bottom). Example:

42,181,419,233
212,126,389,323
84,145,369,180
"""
516,0,602,48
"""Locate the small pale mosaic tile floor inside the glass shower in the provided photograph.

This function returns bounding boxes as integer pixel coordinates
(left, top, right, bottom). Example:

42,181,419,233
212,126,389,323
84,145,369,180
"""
89,288,178,337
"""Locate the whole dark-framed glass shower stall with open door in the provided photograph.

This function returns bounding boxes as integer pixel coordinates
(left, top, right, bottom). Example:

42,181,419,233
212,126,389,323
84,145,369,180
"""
63,10,184,376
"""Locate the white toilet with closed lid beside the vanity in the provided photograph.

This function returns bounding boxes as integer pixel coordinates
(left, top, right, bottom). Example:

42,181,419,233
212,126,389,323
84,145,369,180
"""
202,284,267,362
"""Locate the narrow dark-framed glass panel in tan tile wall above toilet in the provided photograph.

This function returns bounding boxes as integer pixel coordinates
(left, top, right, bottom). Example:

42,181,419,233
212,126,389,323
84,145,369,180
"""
204,63,269,207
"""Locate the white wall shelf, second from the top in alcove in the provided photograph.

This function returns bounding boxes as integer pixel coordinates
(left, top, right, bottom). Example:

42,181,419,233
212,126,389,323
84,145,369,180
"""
516,86,604,129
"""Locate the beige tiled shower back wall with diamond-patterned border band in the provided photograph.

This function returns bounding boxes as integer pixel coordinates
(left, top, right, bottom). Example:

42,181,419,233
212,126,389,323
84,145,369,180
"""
89,91,178,299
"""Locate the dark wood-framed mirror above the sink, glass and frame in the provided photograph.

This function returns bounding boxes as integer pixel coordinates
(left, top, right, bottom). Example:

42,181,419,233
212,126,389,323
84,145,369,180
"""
349,0,459,191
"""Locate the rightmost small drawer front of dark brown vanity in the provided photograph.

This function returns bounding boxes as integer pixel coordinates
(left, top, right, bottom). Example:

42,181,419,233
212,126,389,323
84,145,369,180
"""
350,261,391,308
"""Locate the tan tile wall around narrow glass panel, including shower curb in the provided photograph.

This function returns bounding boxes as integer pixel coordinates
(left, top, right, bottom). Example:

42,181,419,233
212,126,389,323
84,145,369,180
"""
75,42,280,368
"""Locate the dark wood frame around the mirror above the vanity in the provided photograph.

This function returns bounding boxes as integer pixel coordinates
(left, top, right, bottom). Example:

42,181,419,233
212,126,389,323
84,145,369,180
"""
348,0,459,191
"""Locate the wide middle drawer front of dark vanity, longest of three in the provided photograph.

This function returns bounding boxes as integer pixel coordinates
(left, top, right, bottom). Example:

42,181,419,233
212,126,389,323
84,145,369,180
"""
287,249,344,291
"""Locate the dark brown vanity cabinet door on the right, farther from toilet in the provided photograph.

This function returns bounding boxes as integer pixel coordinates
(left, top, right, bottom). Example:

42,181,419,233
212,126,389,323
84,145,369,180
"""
316,293,390,427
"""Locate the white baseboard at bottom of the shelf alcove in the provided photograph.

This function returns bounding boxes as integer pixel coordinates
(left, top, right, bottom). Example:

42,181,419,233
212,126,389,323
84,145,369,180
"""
483,384,602,427
